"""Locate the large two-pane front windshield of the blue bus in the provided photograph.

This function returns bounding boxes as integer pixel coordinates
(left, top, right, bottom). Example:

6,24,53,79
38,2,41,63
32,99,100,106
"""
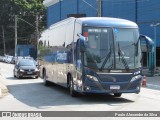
83,27,141,70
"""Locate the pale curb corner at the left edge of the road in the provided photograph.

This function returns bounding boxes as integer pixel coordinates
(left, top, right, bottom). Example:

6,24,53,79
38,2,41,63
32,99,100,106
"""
0,75,8,98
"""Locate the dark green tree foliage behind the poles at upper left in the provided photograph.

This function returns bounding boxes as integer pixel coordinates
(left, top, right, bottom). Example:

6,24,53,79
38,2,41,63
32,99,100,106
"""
0,0,46,55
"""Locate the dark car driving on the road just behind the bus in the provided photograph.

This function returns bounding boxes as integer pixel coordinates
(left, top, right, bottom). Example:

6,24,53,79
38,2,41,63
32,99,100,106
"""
13,59,39,78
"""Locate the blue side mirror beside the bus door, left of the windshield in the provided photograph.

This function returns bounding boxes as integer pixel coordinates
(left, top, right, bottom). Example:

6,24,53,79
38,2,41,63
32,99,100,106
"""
77,34,87,52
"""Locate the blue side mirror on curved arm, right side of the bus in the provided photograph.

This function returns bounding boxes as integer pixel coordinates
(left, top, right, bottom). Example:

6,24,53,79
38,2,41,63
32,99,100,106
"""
139,35,154,52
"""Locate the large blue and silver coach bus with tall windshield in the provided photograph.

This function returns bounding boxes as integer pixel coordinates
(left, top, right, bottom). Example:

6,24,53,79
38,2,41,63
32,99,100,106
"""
38,17,151,97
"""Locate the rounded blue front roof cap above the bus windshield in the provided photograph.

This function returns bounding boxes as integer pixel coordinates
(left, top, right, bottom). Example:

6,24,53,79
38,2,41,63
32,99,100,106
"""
77,17,138,28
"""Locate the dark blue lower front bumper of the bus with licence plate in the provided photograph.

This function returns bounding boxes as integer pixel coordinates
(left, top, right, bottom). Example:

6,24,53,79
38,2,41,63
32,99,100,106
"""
75,79,141,94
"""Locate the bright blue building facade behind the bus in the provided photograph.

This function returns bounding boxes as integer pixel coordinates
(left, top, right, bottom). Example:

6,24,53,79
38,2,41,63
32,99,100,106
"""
44,0,160,66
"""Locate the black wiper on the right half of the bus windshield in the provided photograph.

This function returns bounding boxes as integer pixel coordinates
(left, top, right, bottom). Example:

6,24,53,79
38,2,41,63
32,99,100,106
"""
118,43,129,70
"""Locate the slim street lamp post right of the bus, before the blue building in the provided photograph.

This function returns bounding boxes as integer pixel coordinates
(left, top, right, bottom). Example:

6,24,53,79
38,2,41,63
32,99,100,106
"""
150,23,160,71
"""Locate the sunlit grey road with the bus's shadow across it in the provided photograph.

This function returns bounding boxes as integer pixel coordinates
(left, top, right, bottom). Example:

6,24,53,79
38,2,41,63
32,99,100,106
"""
0,63,160,118
